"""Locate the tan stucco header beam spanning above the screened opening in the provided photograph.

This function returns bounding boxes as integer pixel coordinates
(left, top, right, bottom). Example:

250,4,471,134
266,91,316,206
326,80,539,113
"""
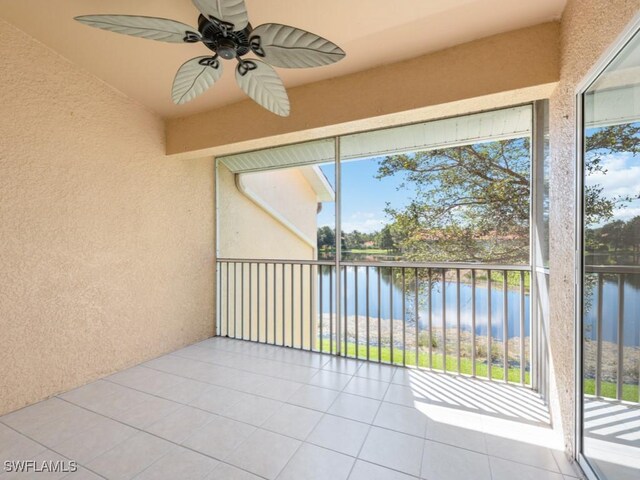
167,22,559,155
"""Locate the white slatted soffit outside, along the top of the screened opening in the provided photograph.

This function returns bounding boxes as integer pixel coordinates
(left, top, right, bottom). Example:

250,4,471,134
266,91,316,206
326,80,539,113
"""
220,105,532,173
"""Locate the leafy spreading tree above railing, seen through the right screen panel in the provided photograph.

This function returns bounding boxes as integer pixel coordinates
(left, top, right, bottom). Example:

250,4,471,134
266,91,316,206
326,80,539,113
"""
378,139,530,263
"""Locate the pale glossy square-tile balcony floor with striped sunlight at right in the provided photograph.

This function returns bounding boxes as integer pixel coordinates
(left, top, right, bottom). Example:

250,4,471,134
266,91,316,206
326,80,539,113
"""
0,338,578,480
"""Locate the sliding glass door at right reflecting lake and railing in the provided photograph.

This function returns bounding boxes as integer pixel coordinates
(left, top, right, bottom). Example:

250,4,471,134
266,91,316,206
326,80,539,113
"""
580,27,640,480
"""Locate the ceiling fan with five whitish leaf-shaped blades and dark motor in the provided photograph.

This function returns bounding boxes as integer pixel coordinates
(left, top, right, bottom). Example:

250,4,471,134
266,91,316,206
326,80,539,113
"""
75,0,345,117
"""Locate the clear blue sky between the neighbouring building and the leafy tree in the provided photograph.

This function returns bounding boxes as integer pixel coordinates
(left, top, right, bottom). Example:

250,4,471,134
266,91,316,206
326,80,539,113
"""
318,158,415,233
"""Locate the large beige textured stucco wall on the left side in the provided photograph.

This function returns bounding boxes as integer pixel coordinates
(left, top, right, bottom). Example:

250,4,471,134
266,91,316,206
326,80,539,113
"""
0,21,215,414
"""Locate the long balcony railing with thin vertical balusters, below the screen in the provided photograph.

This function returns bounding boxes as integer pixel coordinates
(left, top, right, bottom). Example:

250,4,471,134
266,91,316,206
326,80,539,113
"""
217,259,535,385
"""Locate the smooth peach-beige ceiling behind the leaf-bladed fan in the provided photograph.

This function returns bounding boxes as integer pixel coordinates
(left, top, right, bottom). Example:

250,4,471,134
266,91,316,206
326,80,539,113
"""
0,0,566,117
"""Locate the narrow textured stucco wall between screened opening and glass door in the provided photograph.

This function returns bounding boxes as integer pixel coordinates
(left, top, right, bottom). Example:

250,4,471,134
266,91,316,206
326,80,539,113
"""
550,0,640,451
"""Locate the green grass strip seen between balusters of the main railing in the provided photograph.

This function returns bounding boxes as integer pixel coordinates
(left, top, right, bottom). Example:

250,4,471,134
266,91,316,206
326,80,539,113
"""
322,340,530,384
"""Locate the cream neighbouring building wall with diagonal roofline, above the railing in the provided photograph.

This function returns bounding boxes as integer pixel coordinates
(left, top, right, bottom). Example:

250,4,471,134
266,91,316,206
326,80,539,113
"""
218,164,317,260
